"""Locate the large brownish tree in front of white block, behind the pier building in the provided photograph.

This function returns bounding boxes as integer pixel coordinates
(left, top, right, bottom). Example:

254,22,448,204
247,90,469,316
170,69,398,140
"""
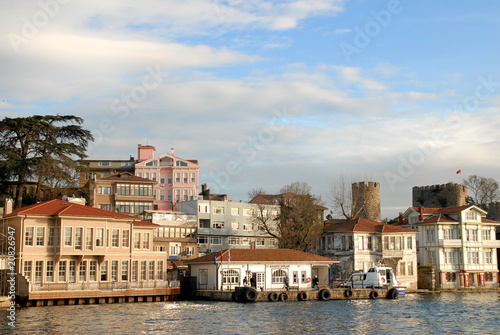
251,182,325,251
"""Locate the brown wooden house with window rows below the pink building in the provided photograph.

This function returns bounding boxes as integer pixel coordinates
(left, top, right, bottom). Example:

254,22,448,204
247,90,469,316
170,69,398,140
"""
90,172,158,216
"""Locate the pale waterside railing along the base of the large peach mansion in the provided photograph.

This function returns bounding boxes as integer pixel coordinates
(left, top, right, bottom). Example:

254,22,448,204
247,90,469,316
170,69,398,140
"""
30,280,180,292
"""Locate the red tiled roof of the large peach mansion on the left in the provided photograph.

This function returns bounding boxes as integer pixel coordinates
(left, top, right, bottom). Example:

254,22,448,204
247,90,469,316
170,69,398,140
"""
5,199,137,220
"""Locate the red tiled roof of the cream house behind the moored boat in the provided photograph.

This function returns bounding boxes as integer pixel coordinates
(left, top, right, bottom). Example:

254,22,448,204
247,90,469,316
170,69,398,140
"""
325,218,418,233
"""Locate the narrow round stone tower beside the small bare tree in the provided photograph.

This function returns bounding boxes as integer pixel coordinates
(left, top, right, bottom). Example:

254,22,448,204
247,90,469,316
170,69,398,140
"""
352,181,382,222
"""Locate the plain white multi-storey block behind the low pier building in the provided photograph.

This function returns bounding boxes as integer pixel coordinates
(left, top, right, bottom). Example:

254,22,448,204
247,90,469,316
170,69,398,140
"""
179,199,279,255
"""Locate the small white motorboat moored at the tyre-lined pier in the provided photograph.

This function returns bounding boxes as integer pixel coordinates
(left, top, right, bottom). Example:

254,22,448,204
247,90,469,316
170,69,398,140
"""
341,266,406,296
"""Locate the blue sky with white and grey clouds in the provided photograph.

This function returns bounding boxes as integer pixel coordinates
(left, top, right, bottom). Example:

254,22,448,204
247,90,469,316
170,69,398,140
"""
0,0,500,218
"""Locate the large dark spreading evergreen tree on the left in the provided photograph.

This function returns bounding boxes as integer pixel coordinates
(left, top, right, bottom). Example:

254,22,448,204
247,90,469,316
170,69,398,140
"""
0,115,94,208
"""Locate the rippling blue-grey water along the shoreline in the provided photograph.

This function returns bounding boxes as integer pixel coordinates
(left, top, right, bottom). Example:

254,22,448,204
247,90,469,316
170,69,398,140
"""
0,292,500,334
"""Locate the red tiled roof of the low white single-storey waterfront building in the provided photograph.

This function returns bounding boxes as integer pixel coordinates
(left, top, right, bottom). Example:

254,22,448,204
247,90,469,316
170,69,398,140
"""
186,249,338,264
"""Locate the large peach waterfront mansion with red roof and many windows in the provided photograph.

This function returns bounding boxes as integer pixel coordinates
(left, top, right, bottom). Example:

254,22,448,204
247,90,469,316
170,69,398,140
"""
1,200,178,305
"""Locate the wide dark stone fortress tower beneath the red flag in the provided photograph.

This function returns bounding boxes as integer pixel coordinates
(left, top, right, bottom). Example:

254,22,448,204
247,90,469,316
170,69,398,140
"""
412,183,467,208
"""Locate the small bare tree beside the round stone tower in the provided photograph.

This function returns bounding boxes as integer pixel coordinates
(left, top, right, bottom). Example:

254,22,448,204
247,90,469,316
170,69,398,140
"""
328,174,367,220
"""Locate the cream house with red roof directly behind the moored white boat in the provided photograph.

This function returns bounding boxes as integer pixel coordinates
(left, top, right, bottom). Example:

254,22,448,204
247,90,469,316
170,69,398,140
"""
318,218,417,291
